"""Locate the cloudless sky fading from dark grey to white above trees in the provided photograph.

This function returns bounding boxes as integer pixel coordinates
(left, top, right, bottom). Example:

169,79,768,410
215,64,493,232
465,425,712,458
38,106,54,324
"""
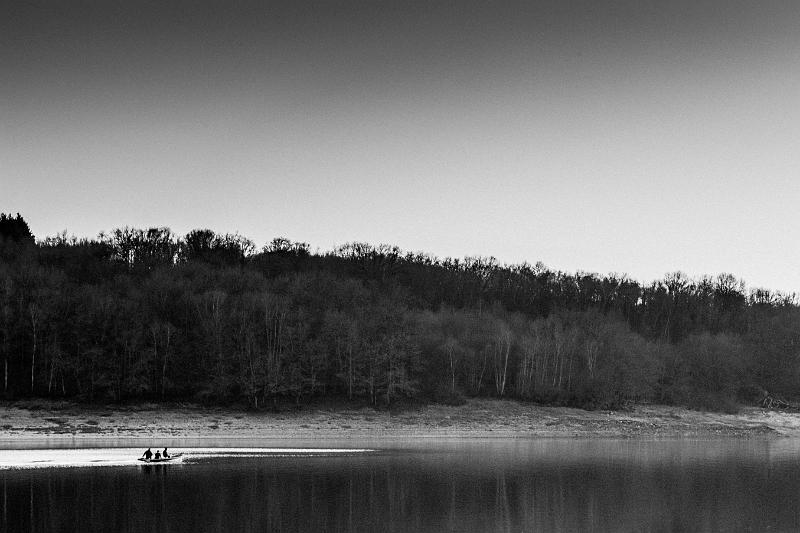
0,0,800,292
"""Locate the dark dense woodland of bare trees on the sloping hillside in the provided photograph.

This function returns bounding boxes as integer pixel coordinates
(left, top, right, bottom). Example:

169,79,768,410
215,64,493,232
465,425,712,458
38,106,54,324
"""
0,215,800,410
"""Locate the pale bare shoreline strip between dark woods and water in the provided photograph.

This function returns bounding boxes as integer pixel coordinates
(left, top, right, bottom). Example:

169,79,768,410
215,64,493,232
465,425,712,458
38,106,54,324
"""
0,400,800,441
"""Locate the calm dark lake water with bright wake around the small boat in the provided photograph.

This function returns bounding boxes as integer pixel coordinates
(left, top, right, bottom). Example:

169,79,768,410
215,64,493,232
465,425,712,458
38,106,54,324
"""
0,440,800,532
